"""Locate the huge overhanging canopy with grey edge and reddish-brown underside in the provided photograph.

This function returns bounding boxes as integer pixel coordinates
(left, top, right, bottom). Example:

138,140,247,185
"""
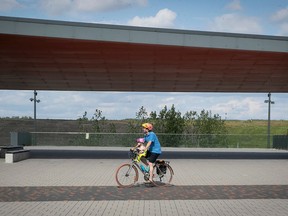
0,17,288,92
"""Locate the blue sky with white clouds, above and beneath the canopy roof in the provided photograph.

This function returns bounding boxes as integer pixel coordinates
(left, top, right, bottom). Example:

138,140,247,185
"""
0,0,288,120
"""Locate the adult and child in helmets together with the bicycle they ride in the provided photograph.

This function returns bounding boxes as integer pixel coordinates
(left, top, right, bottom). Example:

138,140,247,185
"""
115,123,174,187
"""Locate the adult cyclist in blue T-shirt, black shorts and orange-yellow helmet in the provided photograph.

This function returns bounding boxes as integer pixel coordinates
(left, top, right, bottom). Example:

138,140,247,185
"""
142,123,161,182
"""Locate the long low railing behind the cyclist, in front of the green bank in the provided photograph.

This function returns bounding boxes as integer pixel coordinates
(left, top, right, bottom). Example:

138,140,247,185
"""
32,132,272,148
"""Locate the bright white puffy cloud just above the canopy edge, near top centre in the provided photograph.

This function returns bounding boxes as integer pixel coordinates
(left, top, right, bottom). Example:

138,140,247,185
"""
128,8,177,28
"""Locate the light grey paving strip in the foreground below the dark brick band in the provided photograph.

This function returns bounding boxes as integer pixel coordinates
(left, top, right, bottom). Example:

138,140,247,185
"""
0,199,288,216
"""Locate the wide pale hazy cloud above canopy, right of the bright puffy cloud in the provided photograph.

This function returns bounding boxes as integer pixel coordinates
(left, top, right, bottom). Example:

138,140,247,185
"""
210,13,262,34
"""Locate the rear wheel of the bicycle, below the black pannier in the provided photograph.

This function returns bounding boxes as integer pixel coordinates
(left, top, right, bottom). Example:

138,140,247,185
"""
153,164,174,186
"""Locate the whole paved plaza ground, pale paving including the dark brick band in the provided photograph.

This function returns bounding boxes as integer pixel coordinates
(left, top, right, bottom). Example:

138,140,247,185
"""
0,147,288,216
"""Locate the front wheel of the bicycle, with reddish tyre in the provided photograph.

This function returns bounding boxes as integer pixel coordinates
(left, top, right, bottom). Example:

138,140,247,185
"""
115,164,138,187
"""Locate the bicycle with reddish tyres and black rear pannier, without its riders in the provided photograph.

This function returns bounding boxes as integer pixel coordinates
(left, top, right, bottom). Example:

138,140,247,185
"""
115,150,174,187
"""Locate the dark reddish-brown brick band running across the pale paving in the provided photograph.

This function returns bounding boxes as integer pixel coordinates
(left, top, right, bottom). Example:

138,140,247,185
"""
0,185,288,202
